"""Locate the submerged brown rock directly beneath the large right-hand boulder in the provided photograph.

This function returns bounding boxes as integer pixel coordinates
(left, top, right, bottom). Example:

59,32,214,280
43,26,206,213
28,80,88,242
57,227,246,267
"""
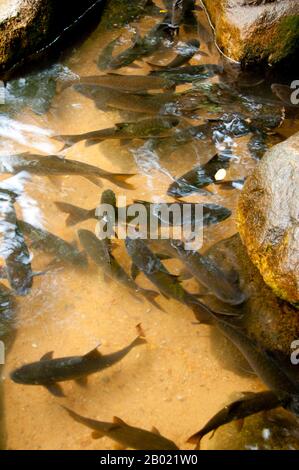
207,234,299,348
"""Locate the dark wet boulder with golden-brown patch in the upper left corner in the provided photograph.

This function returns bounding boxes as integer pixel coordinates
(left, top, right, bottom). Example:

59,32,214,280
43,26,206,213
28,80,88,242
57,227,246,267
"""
0,0,105,72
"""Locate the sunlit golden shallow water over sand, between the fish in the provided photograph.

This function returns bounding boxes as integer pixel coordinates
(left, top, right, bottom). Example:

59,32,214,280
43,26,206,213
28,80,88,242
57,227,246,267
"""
0,0,299,449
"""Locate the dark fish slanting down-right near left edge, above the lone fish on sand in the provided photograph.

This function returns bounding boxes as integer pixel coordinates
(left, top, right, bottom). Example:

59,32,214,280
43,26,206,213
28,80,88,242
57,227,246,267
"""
17,219,87,267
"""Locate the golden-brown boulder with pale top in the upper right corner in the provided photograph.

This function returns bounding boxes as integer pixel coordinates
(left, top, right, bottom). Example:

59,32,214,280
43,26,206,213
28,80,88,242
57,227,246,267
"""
203,0,299,65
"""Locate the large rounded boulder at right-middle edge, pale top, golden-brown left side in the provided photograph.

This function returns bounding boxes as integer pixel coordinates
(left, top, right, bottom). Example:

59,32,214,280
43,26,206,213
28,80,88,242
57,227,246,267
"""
238,133,299,307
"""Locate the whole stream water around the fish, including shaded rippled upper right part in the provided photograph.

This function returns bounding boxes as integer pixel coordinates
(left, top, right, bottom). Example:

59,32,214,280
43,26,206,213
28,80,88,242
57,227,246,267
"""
0,1,299,450
